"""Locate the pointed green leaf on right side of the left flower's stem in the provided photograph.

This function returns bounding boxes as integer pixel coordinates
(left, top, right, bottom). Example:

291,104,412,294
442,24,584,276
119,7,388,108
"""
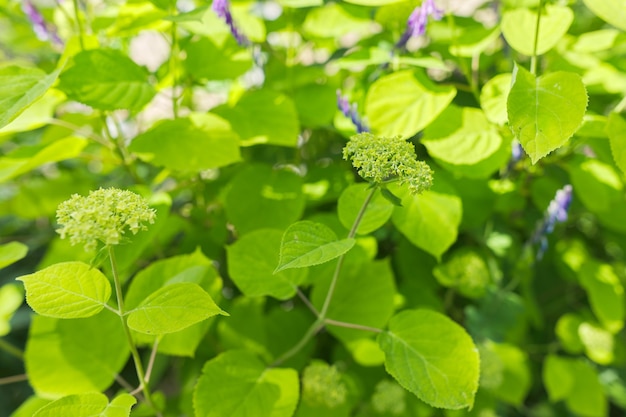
128,282,228,334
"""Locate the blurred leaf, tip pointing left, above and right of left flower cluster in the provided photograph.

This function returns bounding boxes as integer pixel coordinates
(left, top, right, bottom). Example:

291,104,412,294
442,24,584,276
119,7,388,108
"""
128,113,241,172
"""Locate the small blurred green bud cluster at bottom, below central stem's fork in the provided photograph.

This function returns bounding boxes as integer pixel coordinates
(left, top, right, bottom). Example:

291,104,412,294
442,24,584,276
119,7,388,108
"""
302,361,348,408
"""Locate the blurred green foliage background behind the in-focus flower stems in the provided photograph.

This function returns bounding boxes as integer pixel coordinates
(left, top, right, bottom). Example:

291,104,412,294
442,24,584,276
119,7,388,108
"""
0,0,626,417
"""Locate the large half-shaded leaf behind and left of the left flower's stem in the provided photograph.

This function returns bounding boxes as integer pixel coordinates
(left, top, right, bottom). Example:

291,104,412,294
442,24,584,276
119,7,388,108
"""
24,310,130,398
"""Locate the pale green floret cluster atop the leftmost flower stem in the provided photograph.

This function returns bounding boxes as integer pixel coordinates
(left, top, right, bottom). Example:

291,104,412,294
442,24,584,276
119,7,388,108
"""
57,188,156,251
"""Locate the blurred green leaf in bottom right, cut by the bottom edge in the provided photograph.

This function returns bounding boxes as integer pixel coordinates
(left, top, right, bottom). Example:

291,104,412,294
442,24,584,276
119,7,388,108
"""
543,355,608,417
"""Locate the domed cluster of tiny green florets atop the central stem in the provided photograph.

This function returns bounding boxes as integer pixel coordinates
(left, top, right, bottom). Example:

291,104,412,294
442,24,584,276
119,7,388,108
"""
343,133,433,194
